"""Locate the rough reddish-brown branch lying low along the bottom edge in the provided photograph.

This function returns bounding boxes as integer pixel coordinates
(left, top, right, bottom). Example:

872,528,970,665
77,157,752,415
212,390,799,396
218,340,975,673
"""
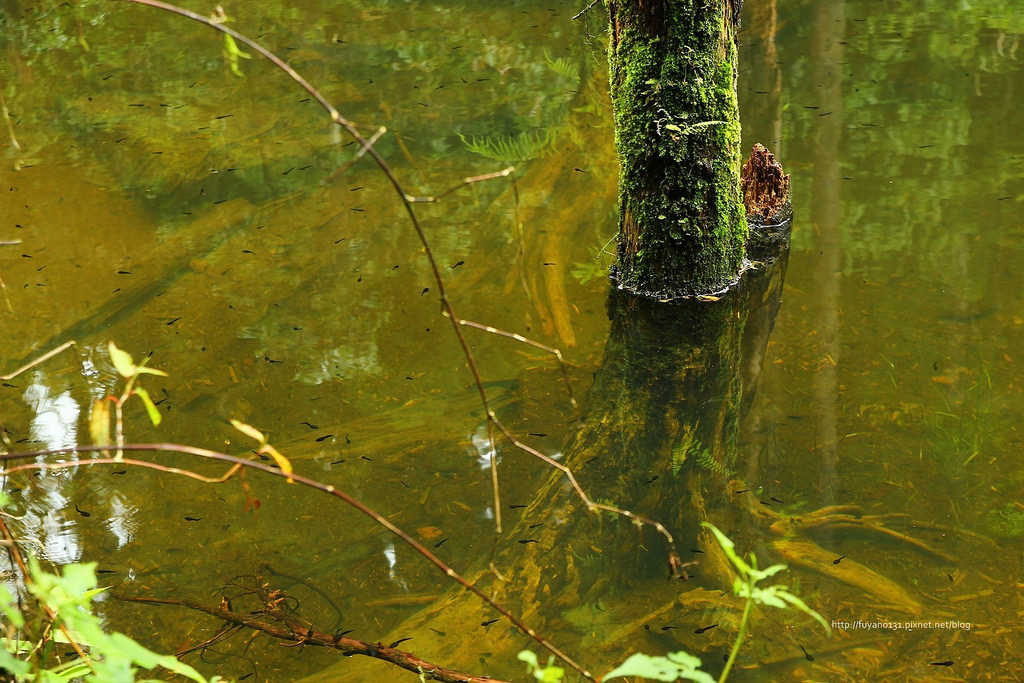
115,595,503,683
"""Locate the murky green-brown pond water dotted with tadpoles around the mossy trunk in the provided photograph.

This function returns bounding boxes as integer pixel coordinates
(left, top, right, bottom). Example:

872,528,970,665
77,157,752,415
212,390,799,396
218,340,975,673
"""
0,0,1024,680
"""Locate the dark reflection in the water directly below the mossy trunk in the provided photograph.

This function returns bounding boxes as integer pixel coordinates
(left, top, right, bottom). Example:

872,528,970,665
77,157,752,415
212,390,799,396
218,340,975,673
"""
307,244,784,680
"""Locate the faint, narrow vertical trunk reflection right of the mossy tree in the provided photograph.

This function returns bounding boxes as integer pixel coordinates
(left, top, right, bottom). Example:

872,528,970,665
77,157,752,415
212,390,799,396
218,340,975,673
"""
811,2,846,505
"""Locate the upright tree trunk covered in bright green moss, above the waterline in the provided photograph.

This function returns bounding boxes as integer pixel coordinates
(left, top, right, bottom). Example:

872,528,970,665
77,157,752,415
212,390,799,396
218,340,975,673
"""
607,0,746,298
